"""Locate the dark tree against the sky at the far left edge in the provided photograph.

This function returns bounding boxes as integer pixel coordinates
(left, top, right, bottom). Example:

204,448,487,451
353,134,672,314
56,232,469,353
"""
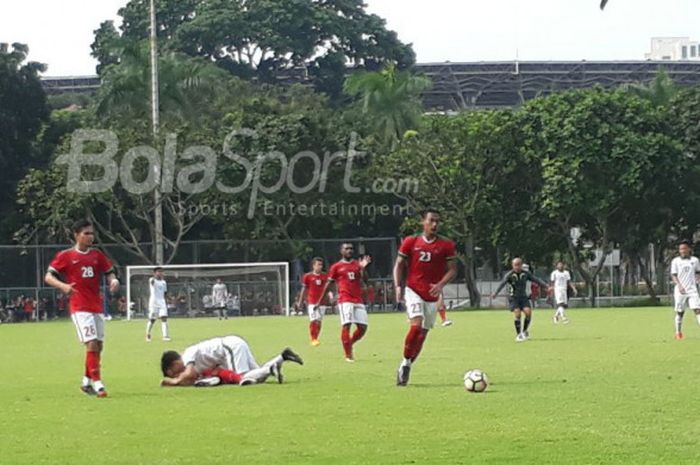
0,43,49,243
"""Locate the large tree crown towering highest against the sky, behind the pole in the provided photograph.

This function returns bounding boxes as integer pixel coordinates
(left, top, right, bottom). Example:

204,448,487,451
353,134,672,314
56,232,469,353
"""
93,0,415,97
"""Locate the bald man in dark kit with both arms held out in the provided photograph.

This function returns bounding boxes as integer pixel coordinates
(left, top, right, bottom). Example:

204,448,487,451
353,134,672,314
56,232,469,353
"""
491,258,549,342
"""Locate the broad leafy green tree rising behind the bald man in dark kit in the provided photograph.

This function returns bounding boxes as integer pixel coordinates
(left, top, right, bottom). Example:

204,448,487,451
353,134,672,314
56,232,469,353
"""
520,88,676,302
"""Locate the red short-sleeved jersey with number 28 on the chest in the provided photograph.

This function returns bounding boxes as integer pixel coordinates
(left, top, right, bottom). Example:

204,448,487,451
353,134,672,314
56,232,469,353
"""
49,248,113,313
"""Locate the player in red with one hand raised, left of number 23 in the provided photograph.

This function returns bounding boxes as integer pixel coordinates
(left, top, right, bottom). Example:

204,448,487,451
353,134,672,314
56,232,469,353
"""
321,242,372,362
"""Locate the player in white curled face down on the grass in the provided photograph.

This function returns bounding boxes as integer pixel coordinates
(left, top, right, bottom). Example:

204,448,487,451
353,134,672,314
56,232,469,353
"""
160,336,304,386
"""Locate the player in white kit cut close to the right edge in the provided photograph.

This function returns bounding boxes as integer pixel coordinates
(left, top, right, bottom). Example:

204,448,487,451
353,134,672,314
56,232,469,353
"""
671,241,700,341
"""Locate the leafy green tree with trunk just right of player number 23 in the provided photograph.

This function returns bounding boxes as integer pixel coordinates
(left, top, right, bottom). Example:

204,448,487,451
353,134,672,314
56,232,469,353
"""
373,111,537,307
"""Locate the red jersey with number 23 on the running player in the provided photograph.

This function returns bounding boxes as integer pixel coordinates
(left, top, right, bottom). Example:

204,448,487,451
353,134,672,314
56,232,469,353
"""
399,235,457,302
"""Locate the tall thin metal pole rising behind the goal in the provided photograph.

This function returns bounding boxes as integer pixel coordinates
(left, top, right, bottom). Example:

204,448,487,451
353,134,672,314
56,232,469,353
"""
150,0,163,265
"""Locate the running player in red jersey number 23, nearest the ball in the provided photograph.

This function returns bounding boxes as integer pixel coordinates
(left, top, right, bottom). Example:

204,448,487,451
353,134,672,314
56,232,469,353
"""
394,209,457,386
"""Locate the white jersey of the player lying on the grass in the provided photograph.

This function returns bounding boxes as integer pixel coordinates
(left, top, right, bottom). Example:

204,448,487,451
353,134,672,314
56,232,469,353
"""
182,336,258,374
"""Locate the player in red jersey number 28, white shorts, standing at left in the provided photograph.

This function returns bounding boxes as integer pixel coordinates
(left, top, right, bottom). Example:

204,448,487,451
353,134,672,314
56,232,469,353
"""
44,220,119,397
